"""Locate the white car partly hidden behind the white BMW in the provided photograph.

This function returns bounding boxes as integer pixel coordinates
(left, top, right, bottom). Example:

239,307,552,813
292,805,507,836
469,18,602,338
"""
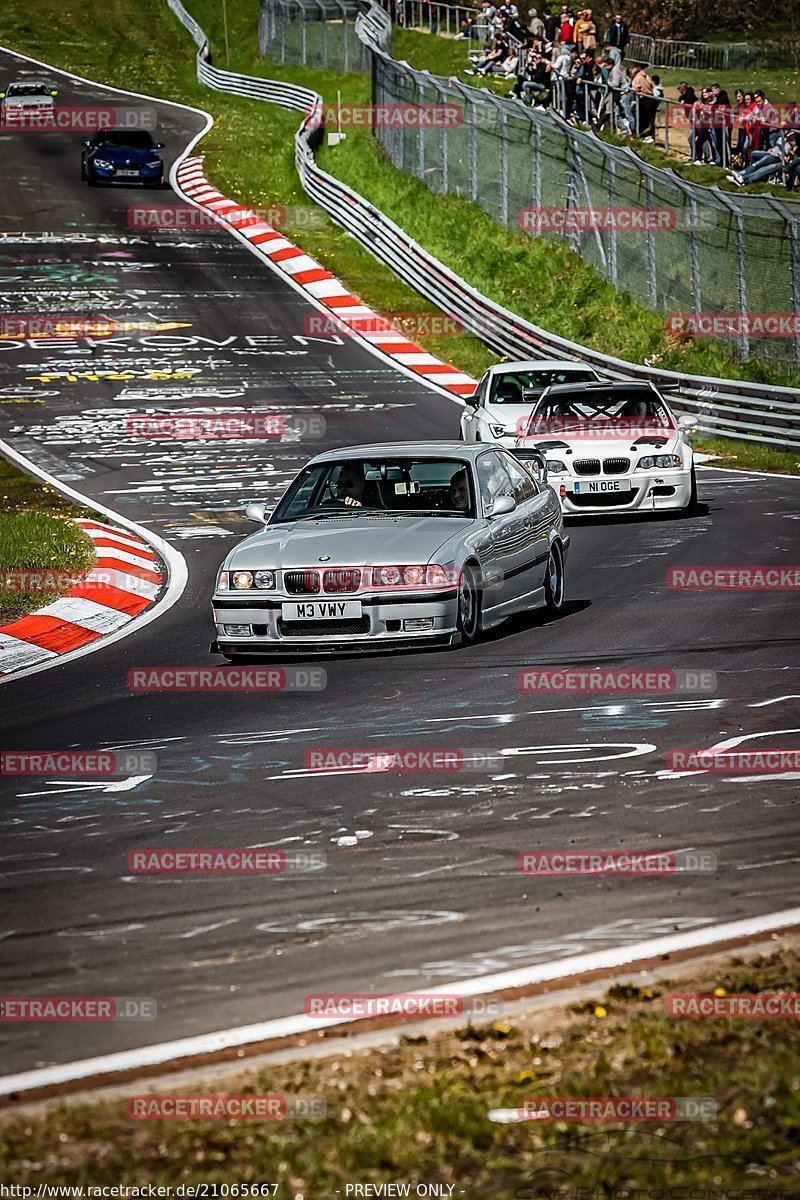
461,359,600,448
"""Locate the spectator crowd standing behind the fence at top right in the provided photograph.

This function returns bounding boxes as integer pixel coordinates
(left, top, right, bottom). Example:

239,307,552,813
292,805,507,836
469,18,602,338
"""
443,0,800,191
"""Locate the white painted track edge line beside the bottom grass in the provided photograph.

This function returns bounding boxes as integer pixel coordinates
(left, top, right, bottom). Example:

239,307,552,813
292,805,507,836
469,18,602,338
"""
0,908,800,1096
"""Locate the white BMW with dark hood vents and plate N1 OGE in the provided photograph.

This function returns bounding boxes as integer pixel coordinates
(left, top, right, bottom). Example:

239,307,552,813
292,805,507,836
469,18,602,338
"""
517,383,697,516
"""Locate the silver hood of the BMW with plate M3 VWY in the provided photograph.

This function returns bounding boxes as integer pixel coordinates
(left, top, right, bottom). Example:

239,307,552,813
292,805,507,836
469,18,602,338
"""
228,515,475,570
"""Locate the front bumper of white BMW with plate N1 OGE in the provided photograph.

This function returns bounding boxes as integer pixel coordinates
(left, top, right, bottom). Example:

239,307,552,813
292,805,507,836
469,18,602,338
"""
547,468,692,516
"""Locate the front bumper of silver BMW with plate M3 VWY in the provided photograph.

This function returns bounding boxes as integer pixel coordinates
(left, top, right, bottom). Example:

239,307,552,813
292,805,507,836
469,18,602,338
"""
212,589,458,655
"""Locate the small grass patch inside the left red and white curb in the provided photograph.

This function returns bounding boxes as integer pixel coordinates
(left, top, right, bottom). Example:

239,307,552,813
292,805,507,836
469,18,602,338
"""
0,458,95,624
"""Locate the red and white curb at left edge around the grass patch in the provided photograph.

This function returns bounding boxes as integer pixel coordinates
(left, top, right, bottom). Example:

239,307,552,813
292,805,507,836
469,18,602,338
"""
0,520,164,677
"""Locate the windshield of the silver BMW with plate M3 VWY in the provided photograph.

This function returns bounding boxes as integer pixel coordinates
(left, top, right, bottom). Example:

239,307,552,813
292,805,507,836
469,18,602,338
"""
270,457,475,524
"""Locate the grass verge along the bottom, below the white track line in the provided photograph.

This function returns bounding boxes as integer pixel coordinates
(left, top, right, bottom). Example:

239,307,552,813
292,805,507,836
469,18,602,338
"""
0,946,800,1200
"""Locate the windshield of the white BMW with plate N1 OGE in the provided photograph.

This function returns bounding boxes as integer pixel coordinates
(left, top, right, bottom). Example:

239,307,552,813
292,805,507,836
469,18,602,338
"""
527,388,675,438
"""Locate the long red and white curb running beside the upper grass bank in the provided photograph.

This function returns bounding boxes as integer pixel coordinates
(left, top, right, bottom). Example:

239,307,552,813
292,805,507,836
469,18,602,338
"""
175,157,475,396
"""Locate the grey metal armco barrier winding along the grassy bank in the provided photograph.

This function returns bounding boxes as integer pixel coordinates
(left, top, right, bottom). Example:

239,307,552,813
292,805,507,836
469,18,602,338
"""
168,0,800,450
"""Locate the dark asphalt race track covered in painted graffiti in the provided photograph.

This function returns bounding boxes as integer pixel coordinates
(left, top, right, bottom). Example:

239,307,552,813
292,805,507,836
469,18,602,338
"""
0,55,800,1072
